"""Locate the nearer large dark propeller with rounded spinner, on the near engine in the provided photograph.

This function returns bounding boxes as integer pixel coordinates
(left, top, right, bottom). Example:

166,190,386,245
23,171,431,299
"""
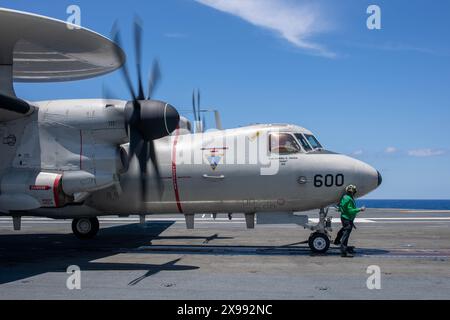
112,17,180,202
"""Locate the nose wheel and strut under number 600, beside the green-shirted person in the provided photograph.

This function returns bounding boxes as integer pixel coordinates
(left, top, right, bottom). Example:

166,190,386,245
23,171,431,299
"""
305,208,333,253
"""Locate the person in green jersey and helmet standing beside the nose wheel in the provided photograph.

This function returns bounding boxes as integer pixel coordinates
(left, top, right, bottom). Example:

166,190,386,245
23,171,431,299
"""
334,185,366,258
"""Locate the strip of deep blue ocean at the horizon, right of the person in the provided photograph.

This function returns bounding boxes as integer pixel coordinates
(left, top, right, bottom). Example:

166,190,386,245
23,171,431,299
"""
356,199,450,210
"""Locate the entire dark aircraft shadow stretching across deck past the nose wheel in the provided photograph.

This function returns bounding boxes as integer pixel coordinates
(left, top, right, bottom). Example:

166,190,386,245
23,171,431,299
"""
0,221,389,286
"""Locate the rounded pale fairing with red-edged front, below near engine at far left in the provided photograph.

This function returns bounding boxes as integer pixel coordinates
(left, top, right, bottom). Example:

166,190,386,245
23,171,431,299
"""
0,171,71,211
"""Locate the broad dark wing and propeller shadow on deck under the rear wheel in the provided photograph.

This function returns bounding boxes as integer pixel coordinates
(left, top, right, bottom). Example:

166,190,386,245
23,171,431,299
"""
0,221,199,285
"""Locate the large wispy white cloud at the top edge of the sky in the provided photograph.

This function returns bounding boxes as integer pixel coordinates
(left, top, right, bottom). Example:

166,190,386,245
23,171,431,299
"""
195,0,336,58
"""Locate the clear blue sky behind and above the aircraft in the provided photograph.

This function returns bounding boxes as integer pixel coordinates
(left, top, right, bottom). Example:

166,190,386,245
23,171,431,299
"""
0,0,450,199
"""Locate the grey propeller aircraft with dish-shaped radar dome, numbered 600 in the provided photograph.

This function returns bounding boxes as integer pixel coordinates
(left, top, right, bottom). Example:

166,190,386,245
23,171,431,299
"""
0,9,381,252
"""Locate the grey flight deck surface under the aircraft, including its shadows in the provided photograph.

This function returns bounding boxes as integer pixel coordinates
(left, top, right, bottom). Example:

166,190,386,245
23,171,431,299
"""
0,209,450,300
